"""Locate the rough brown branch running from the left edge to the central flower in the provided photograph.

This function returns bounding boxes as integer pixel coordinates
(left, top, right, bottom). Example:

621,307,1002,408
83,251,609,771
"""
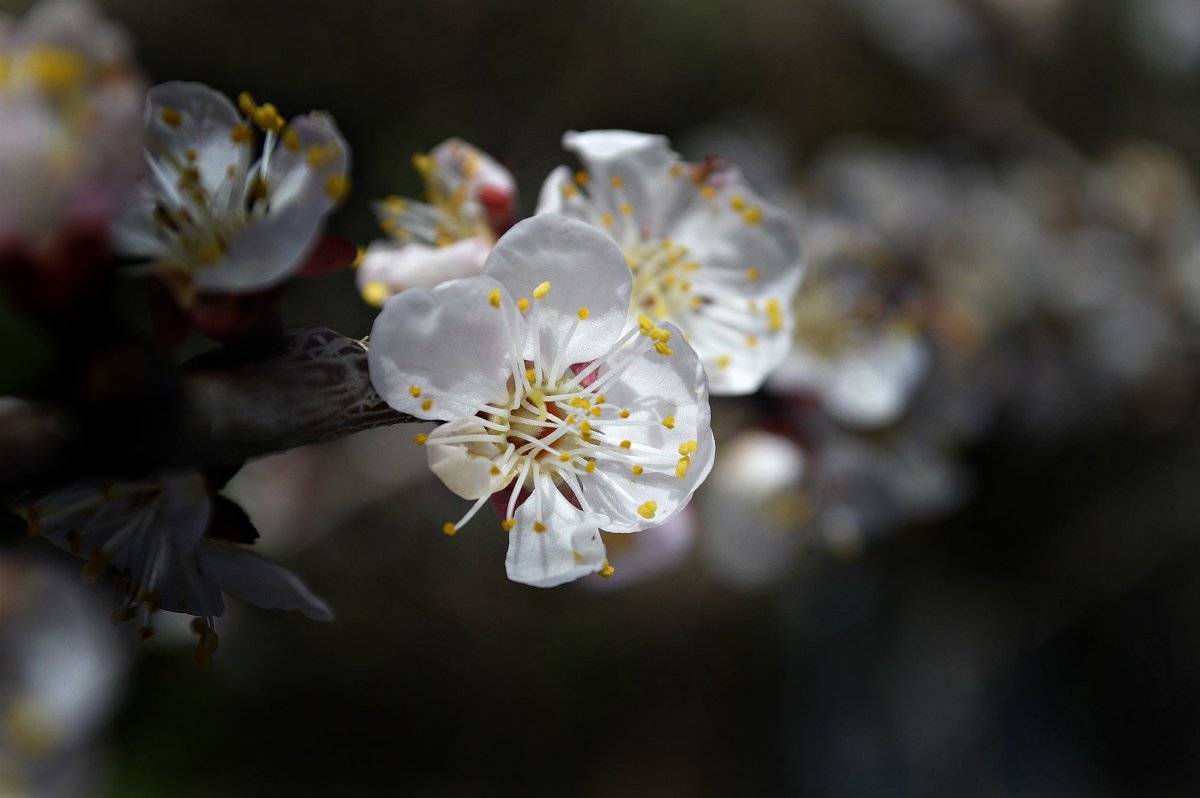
0,328,416,496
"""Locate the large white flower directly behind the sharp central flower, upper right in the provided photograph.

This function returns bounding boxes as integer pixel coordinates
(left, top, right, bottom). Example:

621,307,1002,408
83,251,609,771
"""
538,131,802,395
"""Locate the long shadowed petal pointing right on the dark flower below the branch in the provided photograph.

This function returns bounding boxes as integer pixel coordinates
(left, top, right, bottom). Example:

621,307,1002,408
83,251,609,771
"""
197,539,334,620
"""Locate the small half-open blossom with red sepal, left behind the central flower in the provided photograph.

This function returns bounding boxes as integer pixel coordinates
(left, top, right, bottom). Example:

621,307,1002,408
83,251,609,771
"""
358,138,517,305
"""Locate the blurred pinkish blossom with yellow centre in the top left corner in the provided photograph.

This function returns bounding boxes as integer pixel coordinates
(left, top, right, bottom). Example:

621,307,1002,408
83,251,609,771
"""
0,0,144,256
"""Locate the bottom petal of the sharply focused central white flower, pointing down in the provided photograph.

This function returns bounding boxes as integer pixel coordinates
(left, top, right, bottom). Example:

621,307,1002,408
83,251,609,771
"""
504,479,605,588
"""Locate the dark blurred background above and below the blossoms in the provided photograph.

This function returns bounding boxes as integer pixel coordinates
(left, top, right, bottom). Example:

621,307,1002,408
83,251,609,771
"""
7,0,1200,798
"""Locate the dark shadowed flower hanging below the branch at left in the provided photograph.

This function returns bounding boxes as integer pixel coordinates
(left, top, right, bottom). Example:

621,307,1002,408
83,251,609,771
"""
17,472,334,660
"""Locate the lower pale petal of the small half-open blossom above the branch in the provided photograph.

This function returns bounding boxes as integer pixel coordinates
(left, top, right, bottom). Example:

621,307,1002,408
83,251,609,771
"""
356,236,492,294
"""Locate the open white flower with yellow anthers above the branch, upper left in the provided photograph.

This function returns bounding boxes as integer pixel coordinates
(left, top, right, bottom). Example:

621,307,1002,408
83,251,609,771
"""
114,82,349,308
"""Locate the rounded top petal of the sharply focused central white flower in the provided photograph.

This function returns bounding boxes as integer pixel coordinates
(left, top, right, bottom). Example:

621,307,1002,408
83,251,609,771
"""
482,214,632,368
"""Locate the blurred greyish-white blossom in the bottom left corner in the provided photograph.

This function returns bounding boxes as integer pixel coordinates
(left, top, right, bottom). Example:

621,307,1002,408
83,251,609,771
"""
0,556,130,798
